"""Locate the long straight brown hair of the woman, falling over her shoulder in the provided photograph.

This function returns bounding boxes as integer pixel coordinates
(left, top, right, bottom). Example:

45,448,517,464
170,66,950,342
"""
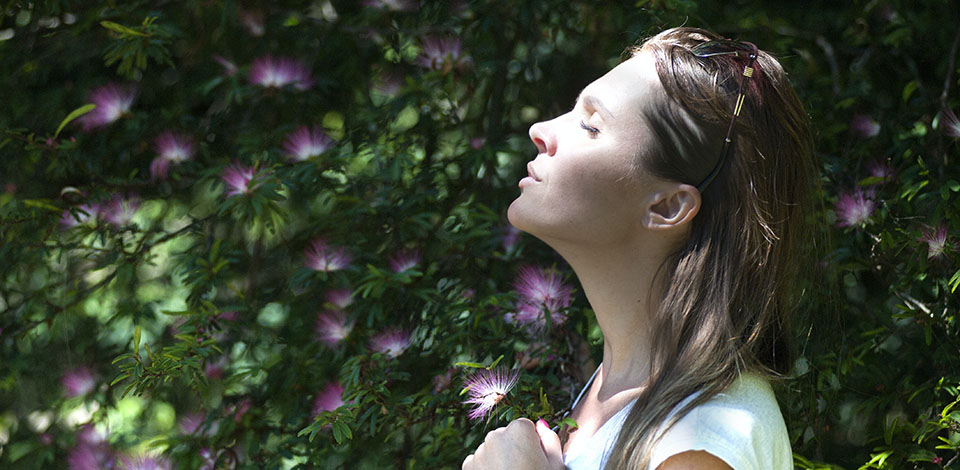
606,27,816,470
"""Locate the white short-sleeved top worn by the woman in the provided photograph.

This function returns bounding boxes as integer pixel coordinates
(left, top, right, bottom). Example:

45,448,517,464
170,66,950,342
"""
563,368,793,470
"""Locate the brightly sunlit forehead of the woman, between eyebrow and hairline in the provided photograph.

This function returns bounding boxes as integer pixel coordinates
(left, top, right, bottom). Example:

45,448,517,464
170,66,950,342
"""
581,52,661,117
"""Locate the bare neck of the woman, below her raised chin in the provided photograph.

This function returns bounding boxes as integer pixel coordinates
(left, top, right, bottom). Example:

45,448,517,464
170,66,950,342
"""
551,235,666,398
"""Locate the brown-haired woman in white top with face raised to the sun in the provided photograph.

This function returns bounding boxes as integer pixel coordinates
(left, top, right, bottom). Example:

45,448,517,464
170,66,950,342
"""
463,28,814,470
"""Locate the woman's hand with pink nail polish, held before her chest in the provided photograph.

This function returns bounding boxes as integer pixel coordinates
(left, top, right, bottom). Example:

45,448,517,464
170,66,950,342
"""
462,418,564,470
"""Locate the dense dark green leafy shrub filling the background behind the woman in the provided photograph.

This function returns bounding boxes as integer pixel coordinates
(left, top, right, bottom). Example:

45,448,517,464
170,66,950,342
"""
0,0,960,469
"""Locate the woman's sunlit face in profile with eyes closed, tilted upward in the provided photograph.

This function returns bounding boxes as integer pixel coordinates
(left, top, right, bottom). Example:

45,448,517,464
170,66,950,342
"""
507,53,663,243
